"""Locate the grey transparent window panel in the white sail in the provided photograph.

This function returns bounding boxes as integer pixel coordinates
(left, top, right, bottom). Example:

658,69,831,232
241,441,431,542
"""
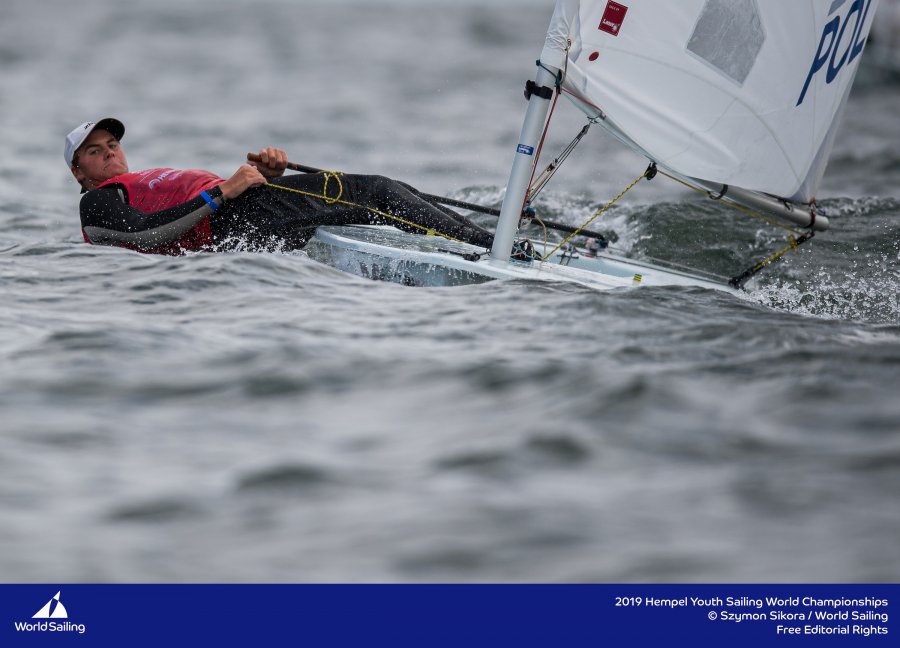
687,0,766,85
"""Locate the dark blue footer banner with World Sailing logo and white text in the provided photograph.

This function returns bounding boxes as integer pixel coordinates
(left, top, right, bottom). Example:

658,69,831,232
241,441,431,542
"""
0,584,900,648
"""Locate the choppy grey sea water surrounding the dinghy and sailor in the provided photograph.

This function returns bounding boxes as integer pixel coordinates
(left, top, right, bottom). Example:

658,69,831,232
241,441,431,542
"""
0,0,900,582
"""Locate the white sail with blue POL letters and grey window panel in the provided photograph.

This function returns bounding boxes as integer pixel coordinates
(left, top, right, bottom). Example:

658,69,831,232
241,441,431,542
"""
541,0,878,203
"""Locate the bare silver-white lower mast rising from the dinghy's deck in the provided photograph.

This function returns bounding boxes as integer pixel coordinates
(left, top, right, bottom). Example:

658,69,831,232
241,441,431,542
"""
491,61,557,266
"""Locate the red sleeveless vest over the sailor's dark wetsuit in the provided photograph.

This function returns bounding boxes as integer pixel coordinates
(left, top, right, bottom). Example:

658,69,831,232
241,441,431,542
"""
94,168,224,254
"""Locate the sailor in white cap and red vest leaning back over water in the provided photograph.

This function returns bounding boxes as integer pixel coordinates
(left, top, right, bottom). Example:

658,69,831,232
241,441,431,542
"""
65,117,493,254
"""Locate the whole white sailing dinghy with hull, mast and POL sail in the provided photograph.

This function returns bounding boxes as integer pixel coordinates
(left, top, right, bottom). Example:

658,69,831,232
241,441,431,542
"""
300,0,878,290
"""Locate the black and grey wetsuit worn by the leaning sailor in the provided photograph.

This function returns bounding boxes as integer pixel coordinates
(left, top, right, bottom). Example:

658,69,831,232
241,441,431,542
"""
81,174,493,249
